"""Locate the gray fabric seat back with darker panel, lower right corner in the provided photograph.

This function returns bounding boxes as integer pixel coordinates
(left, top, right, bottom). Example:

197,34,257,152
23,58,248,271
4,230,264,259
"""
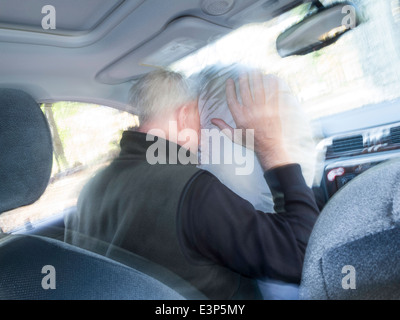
300,159,400,300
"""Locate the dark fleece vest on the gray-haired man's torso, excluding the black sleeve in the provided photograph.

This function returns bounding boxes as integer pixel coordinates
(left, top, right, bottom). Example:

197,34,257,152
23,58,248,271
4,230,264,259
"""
65,131,260,299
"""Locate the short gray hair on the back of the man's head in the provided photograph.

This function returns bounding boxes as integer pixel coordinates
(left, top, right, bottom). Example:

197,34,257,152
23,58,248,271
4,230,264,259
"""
129,69,197,125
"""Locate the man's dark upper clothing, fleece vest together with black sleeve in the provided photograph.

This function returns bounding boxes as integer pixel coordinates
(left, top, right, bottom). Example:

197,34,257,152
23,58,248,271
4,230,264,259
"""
66,131,318,299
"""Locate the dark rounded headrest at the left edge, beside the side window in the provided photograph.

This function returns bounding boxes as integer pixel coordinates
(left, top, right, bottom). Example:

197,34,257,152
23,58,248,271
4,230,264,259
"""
0,89,53,213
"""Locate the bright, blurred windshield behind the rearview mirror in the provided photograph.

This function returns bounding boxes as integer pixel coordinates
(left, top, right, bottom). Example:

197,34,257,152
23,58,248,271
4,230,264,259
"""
171,0,400,119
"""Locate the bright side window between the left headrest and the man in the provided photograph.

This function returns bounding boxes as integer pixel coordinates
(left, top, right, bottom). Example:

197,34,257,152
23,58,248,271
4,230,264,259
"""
0,102,139,233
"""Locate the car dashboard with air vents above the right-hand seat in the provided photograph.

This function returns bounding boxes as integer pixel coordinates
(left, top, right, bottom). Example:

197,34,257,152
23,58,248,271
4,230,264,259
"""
312,100,400,203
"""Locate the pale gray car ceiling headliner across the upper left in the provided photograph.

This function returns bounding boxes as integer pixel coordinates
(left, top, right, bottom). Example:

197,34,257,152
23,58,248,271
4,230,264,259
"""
0,0,303,110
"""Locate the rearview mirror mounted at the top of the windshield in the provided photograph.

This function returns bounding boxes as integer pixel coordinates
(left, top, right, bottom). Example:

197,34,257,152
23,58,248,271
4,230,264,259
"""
276,2,359,58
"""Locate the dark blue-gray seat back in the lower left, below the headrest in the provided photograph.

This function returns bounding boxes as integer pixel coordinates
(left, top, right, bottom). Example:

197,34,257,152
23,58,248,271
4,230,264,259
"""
0,235,183,300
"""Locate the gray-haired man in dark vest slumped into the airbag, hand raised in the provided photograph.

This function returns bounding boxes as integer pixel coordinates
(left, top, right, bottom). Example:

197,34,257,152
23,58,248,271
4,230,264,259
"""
66,71,318,299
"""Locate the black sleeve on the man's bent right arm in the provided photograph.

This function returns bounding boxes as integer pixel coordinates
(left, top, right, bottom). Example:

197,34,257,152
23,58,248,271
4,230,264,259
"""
178,164,319,283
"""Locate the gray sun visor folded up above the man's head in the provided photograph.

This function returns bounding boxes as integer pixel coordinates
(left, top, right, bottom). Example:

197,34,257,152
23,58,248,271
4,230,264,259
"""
96,17,232,84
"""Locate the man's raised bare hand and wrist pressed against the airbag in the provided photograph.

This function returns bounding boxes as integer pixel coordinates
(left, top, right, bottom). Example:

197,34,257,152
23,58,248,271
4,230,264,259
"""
212,72,291,171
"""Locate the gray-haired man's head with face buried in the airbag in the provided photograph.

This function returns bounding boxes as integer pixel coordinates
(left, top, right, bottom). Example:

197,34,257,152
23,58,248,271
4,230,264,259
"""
130,70,200,151
